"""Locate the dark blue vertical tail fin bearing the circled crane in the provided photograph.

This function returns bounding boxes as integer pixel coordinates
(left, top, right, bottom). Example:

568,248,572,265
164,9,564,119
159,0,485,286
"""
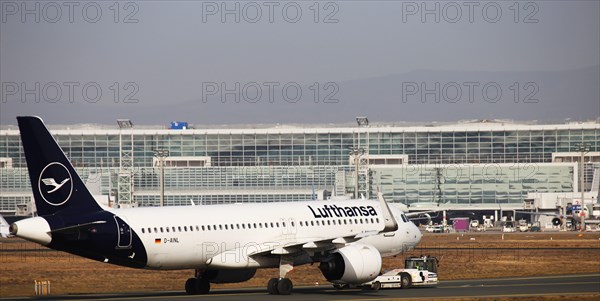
17,117,102,216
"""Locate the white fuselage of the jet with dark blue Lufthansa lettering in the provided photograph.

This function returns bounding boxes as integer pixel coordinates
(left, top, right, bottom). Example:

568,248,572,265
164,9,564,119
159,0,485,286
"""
110,200,421,269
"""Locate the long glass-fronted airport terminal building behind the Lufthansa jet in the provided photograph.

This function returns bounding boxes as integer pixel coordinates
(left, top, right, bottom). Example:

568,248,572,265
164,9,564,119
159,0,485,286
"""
0,118,600,215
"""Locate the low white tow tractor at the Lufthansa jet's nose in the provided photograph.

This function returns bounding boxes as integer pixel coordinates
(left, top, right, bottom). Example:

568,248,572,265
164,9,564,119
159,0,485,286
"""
360,256,438,290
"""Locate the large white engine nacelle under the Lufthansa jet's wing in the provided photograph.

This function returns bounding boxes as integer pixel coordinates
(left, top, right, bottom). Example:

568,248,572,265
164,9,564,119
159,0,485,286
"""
319,244,381,284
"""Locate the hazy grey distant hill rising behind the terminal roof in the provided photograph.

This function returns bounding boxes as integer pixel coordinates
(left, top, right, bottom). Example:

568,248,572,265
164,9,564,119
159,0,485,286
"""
0,66,600,125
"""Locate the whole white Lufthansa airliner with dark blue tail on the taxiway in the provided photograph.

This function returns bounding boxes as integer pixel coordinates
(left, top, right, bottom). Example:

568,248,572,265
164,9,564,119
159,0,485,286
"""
10,117,421,295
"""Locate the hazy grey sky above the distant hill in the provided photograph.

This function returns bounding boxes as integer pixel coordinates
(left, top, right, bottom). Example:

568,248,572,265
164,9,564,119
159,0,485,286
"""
0,0,600,124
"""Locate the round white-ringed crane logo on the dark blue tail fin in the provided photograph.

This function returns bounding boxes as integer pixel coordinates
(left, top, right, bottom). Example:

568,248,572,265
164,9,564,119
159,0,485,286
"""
38,162,73,206
